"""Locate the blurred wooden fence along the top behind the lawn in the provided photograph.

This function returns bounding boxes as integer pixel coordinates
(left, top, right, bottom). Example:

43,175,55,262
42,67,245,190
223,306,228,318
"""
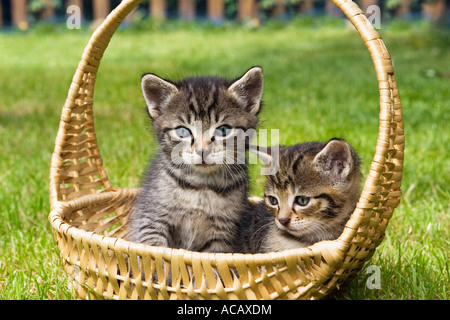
0,0,450,29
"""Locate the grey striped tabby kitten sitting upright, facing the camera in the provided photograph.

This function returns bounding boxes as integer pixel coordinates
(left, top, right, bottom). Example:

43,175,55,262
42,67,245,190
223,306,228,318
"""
129,67,263,252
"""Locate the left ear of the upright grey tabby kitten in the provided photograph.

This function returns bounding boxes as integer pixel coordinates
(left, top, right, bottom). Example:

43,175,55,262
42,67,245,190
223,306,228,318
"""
141,73,178,119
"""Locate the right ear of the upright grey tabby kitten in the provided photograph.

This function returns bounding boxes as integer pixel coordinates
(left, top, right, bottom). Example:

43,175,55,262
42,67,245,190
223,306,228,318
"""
228,67,263,114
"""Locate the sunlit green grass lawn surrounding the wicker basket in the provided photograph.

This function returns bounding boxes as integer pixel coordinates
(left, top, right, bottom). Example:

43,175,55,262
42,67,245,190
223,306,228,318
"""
0,23,450,299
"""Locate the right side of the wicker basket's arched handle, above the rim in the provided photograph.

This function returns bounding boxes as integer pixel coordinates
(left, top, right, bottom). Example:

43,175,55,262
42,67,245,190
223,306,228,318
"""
331,0,405,255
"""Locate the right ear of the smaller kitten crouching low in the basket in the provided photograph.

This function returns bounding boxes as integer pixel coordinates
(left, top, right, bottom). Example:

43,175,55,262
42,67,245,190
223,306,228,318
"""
313,139,355,184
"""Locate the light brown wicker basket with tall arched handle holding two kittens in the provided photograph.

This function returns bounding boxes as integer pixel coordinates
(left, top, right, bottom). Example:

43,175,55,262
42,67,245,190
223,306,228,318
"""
49,0,404,299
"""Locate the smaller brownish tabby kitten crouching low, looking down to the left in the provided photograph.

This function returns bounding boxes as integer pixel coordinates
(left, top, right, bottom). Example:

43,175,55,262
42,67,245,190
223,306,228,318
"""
237,139,361,253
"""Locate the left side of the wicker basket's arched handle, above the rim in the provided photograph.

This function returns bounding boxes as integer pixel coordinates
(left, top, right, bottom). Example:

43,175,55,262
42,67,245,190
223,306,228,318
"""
50,0,142,208
